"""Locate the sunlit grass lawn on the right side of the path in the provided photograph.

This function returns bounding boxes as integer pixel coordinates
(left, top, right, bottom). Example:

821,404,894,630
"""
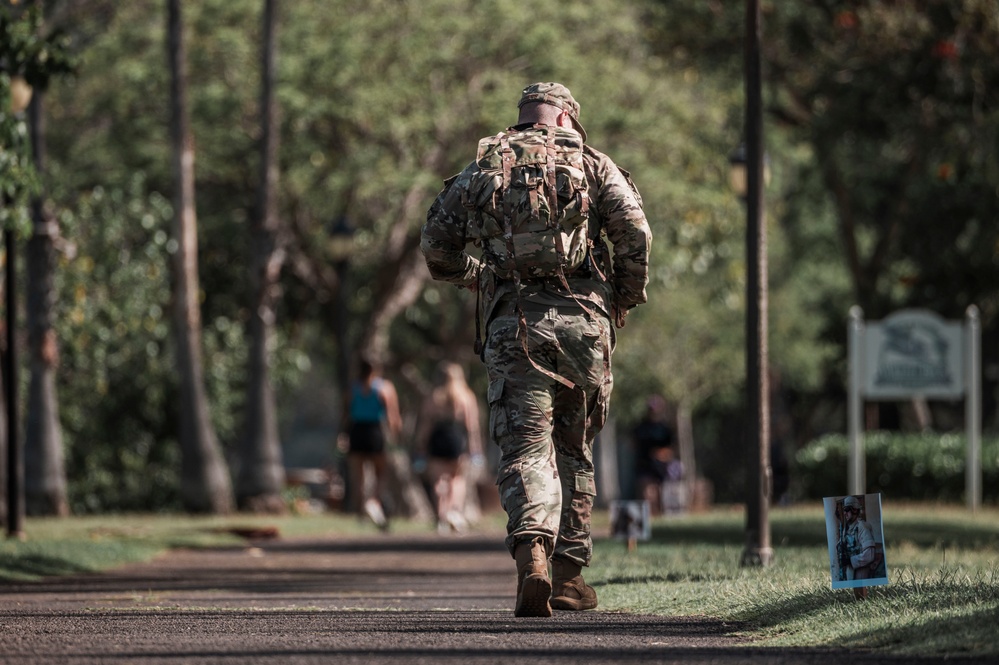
587,503,999,655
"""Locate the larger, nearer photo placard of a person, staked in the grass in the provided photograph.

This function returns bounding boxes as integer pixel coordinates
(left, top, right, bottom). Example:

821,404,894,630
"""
822,494,888,589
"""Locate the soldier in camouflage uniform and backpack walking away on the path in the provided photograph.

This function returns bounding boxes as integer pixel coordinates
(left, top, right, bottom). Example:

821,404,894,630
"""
421,83,652,616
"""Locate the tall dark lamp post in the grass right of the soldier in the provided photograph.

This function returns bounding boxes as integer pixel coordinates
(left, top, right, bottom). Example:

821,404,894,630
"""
729,0,773,566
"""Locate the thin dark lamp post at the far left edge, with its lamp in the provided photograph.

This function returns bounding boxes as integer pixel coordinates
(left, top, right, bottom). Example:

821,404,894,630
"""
0,76,31,539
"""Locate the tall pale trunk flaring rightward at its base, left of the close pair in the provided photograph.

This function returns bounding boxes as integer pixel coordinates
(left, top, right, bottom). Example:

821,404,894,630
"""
167,0,233,513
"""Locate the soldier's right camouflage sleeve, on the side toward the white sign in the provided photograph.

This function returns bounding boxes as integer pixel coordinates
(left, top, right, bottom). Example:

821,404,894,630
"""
586,146,652,310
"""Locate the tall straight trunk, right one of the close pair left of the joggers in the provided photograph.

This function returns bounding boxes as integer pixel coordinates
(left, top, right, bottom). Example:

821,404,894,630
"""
236,0,285,512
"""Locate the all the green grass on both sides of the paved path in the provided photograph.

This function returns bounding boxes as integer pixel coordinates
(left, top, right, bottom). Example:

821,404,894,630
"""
0,503,999,656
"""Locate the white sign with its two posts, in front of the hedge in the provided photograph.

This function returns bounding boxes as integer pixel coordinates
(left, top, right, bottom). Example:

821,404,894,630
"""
847,305,982,511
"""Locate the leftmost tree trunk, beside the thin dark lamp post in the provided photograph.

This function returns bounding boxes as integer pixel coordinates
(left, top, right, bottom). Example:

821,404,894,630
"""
24,91,69,517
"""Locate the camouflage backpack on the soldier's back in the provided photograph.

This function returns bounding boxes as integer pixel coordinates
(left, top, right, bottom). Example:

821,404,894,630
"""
463,125,589,281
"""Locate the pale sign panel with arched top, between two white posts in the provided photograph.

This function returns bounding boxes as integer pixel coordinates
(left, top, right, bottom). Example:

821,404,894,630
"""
862,309,965,400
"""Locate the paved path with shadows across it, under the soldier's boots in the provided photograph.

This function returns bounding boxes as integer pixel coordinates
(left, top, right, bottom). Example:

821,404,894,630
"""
0,534,988,665
